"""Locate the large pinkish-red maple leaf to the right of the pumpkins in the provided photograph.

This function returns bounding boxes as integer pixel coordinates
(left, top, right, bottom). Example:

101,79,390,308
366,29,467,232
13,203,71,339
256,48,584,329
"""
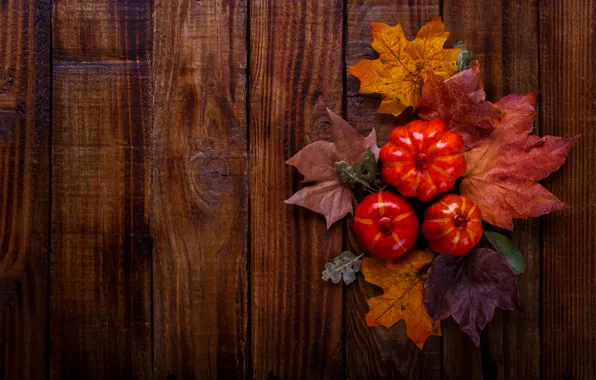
459,93,579,230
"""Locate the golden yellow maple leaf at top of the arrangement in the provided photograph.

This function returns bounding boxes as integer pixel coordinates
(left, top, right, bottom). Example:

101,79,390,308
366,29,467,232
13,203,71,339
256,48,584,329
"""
348,17,460,116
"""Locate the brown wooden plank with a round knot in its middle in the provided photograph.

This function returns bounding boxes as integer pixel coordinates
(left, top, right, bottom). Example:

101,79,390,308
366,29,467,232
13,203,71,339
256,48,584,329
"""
152,0,248,379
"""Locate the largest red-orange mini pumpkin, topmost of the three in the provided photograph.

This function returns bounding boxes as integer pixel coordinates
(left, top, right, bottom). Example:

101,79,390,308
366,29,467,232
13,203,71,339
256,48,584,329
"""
379,120,466,202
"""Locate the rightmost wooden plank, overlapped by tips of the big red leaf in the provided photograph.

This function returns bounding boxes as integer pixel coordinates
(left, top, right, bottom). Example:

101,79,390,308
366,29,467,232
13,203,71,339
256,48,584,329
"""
540,0,596,379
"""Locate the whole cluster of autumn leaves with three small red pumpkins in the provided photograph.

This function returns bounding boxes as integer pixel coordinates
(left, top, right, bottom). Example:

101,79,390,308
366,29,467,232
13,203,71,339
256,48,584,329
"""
286,17,579,349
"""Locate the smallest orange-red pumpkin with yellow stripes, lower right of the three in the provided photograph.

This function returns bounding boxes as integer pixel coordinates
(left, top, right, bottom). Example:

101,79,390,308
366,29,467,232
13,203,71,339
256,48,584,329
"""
422,194,482,256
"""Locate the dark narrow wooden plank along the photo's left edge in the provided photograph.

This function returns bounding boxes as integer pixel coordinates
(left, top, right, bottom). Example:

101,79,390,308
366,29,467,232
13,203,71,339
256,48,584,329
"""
0,0,51,380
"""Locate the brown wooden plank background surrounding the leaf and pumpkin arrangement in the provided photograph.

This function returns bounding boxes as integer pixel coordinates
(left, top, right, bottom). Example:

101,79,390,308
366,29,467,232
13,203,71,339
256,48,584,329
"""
0,0,596,380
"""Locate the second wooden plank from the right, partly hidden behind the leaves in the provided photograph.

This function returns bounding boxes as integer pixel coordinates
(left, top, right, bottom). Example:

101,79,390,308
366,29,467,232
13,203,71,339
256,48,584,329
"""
443,0,540,379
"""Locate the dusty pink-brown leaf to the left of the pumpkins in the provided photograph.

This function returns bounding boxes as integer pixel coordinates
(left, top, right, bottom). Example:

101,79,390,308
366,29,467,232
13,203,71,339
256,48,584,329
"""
285,109,379,229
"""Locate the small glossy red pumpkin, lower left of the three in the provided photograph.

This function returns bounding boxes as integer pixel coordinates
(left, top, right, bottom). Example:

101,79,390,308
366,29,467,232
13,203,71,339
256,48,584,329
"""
353,191,419,257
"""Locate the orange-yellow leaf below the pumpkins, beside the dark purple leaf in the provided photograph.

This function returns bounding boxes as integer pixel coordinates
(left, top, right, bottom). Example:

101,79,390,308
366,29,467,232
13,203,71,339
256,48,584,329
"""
361,249,441,349
